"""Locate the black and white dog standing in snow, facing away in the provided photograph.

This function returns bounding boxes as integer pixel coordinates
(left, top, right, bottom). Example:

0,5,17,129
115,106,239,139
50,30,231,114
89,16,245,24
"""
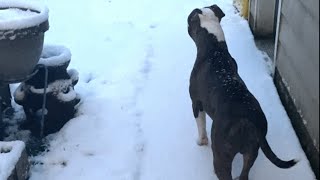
188,5,297,180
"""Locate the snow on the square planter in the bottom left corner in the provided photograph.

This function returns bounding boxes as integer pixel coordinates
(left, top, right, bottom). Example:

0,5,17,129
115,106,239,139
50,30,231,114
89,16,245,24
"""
0,141,25,180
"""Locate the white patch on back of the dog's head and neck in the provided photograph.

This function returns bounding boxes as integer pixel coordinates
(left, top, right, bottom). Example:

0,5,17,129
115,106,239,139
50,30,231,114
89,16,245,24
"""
199,8,225,42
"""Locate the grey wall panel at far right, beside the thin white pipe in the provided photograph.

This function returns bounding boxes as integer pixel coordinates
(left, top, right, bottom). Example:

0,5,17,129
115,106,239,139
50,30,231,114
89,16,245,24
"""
275,0,319,151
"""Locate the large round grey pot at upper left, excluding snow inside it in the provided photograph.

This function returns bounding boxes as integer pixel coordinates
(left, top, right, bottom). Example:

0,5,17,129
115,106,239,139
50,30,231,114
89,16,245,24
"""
0,1,49,84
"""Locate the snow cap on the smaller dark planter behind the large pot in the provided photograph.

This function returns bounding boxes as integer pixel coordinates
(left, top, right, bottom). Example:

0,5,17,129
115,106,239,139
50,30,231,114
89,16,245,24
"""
38,44,71,66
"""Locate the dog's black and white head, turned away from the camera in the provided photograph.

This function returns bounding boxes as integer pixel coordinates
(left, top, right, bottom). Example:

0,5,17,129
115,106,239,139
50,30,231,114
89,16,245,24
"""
188,4,225,43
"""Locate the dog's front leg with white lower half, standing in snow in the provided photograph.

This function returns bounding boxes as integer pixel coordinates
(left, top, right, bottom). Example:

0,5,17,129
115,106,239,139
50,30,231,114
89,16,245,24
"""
192,102,208,146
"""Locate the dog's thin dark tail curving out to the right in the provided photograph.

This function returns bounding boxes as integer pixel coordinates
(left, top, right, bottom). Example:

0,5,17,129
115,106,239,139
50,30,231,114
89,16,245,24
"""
259,136,298,169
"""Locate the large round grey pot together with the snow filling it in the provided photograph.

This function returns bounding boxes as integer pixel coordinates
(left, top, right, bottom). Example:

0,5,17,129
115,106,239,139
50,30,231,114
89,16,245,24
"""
0,0,49,139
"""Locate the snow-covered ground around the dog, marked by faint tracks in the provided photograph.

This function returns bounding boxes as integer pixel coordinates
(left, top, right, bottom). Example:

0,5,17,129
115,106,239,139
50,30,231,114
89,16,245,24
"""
3,0,315,180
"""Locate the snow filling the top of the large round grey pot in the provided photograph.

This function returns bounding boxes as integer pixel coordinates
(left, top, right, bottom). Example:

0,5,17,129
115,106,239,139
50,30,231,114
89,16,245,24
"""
0,0,48,31
